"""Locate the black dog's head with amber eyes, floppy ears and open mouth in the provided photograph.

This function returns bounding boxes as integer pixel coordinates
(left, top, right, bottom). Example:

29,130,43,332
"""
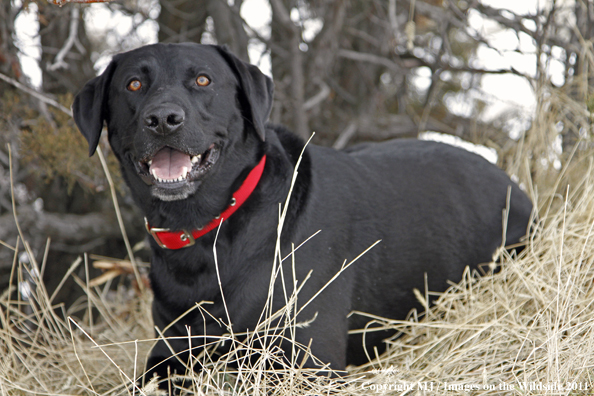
72,43,273,201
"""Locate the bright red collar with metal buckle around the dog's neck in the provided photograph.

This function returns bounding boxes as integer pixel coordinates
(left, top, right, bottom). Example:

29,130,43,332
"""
144,155,266,249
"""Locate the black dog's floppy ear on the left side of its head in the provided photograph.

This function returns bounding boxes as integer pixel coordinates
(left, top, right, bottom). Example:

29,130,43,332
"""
72,61,115,157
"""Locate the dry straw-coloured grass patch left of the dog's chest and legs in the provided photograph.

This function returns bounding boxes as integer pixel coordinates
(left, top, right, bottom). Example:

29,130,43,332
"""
0,255,152,395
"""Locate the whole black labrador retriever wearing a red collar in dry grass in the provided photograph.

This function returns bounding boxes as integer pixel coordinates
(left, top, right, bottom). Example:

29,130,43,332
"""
73,44,532,384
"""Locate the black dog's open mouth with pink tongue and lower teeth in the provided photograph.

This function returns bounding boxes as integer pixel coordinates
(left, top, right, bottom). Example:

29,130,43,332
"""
136,144,220,188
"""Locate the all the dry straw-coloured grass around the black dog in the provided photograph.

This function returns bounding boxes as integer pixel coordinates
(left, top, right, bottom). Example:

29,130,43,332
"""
0,61,594,395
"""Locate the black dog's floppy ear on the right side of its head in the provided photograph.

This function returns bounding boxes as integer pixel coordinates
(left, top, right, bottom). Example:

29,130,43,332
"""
217,46,274,141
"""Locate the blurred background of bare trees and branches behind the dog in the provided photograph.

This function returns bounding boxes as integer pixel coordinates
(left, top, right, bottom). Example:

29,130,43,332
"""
0,0,594,310
